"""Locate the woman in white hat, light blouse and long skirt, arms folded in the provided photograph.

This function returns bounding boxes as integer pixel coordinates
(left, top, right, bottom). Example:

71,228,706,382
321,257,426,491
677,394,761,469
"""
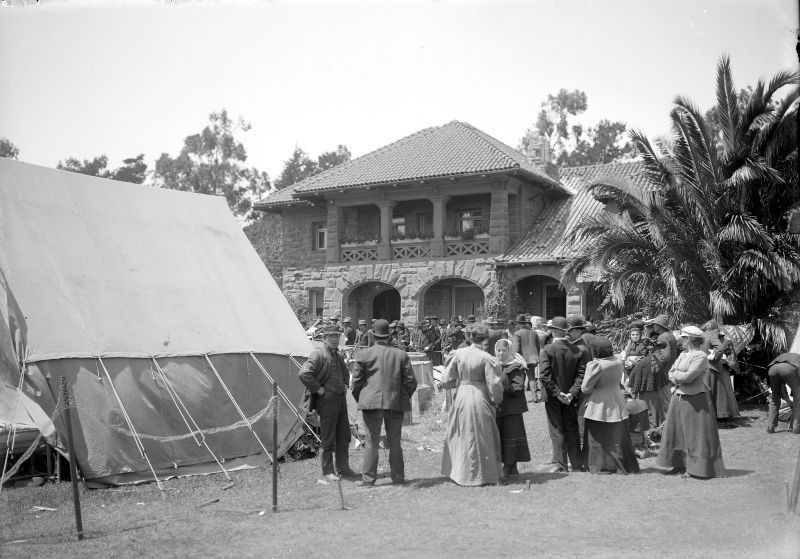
656,326,725,478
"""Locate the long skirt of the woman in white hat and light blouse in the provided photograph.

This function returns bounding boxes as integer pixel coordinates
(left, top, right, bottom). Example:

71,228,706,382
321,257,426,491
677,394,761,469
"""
656,392,725,477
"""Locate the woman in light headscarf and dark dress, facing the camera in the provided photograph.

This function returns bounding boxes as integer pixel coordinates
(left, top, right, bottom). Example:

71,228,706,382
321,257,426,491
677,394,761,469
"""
494,339,531,476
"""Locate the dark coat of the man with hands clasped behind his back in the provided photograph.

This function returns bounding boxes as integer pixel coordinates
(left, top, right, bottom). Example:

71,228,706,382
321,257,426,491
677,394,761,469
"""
539,338,589,407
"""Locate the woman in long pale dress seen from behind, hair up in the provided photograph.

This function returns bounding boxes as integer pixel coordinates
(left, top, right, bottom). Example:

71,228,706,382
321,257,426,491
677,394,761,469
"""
442,326,503,485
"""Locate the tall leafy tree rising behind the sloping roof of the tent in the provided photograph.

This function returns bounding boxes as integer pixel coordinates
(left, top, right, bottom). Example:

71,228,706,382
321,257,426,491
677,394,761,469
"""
153,109,269,221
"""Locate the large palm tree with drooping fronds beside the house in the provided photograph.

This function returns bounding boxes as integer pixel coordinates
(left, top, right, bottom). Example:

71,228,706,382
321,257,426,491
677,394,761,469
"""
564,56,800,349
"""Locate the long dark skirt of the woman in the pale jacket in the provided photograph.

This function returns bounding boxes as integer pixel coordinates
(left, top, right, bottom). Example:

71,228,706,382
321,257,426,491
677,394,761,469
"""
583,419,639,474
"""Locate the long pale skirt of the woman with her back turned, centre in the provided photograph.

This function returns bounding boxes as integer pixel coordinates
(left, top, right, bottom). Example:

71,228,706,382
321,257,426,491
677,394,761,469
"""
442,384,501,485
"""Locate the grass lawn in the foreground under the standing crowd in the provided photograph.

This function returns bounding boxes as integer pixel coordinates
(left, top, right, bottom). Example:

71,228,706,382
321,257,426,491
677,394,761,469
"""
0,390,800,558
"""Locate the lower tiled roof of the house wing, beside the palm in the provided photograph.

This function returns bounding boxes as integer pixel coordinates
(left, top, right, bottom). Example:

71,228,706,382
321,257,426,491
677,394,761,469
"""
496,161,647,265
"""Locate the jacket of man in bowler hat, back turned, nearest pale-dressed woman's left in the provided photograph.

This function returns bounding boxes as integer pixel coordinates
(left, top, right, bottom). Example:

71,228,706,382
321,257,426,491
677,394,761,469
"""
353,339,417,411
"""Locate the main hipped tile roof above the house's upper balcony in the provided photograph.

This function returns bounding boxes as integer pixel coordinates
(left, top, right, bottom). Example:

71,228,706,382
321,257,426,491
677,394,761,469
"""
256,121,566,208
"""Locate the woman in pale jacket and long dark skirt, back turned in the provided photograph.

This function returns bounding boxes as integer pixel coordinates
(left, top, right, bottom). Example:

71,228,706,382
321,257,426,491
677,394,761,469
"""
581,336,639,474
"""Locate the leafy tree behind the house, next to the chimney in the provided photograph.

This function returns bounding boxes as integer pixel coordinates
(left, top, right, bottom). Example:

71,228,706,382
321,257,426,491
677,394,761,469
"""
519,89,632,166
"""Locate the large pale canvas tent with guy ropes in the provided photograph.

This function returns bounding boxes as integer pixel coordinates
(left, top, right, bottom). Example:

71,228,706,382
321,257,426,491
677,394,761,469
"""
0,159,311,483
